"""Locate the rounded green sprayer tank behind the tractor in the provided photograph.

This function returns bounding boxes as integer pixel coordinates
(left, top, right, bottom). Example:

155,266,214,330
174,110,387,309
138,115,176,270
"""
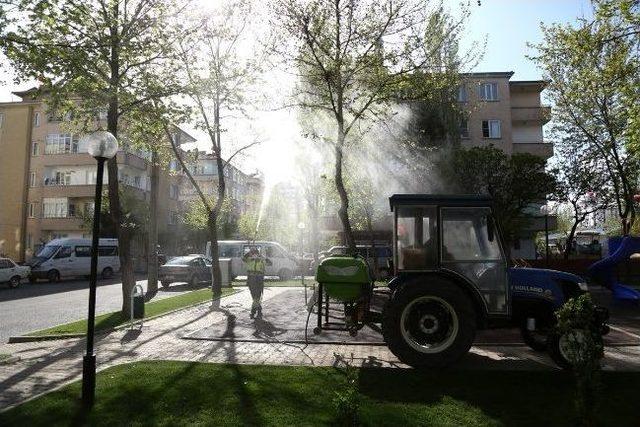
316,256,371,303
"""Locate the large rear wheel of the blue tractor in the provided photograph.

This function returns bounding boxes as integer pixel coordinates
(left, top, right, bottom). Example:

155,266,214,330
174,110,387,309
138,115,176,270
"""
382,279,476,368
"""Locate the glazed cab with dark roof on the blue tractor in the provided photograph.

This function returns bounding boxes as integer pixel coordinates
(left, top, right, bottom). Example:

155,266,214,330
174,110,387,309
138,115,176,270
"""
389,194,510,316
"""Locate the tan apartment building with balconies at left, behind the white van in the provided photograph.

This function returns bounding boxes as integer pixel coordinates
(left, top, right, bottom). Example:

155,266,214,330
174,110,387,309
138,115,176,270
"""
0,90,195,261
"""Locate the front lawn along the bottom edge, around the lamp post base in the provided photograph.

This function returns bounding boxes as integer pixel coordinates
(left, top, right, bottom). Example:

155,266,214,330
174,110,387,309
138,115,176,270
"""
0,361,640,427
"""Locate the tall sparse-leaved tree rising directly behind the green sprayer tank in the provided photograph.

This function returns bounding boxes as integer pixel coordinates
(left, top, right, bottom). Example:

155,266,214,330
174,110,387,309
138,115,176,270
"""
275,0,476,250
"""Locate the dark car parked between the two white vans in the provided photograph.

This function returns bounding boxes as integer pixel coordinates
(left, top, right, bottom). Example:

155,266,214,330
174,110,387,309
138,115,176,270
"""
158,254,211,288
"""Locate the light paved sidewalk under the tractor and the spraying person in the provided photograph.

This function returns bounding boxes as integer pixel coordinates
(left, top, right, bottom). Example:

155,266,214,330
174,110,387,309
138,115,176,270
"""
0,287,640,410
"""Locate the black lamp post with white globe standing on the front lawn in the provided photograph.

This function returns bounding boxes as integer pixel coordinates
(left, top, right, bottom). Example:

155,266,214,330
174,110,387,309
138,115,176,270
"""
80,131,118,409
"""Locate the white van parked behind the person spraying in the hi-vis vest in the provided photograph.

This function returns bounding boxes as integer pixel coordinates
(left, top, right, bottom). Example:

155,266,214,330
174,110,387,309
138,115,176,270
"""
206,240,299,280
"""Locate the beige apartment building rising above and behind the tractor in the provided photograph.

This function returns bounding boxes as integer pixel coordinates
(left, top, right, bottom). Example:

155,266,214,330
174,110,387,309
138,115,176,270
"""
458,72,553,159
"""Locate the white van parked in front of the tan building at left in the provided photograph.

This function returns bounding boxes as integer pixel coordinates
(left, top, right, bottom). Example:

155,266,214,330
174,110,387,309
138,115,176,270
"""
29,238,120,282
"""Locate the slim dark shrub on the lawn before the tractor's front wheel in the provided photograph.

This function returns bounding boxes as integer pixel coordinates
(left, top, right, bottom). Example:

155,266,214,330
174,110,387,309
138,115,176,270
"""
556,294,604,426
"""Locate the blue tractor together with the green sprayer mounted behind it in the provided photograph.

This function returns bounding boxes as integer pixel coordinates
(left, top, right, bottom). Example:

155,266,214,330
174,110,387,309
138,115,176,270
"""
315,194,608,367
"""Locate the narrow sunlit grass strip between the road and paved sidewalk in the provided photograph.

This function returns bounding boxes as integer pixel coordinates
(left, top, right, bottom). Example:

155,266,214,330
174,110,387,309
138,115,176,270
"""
28,288,236,336
